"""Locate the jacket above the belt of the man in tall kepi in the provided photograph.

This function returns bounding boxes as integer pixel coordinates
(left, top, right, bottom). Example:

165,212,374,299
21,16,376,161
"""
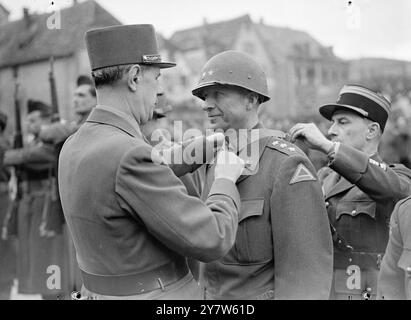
59,106,240,296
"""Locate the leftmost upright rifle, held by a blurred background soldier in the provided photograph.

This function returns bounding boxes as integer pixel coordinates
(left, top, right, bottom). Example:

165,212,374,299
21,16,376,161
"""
1,67,23,240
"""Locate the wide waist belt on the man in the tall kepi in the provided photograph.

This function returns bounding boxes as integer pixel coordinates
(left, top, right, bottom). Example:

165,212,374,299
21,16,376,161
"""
81,260,189,296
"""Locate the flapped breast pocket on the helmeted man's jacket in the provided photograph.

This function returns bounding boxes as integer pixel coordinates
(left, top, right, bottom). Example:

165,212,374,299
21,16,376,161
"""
225,198,272,264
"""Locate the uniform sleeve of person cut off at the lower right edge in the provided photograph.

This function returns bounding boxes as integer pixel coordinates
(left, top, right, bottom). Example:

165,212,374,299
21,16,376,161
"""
377,197,411,300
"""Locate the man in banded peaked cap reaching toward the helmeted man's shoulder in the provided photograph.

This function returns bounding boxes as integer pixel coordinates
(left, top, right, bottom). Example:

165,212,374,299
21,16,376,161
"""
289,85,411,299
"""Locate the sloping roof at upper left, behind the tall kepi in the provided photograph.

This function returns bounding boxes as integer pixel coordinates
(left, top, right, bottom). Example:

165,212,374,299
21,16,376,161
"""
0,0,121,68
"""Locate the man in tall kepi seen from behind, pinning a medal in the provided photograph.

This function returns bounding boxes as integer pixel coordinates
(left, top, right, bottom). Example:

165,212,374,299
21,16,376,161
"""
59,25,244,299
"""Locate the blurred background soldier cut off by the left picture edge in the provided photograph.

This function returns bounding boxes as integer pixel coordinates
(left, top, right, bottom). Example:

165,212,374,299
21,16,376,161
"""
0,111,17,300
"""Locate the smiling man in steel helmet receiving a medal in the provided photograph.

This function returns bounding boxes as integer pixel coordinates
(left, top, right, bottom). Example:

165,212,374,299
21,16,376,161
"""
192,51,332,299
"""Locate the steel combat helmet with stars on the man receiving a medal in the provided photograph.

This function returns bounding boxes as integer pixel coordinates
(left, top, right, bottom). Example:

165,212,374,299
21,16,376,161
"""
192,50,270,102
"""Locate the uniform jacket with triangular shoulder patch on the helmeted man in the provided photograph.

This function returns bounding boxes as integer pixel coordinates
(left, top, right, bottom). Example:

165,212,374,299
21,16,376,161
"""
204,129,332,299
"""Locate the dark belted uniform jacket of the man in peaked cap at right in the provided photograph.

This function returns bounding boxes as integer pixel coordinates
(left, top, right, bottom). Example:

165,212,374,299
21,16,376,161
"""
318,144,411,298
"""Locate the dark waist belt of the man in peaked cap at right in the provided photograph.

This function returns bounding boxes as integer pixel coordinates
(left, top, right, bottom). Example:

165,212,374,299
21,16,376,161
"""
334,252,384,270
